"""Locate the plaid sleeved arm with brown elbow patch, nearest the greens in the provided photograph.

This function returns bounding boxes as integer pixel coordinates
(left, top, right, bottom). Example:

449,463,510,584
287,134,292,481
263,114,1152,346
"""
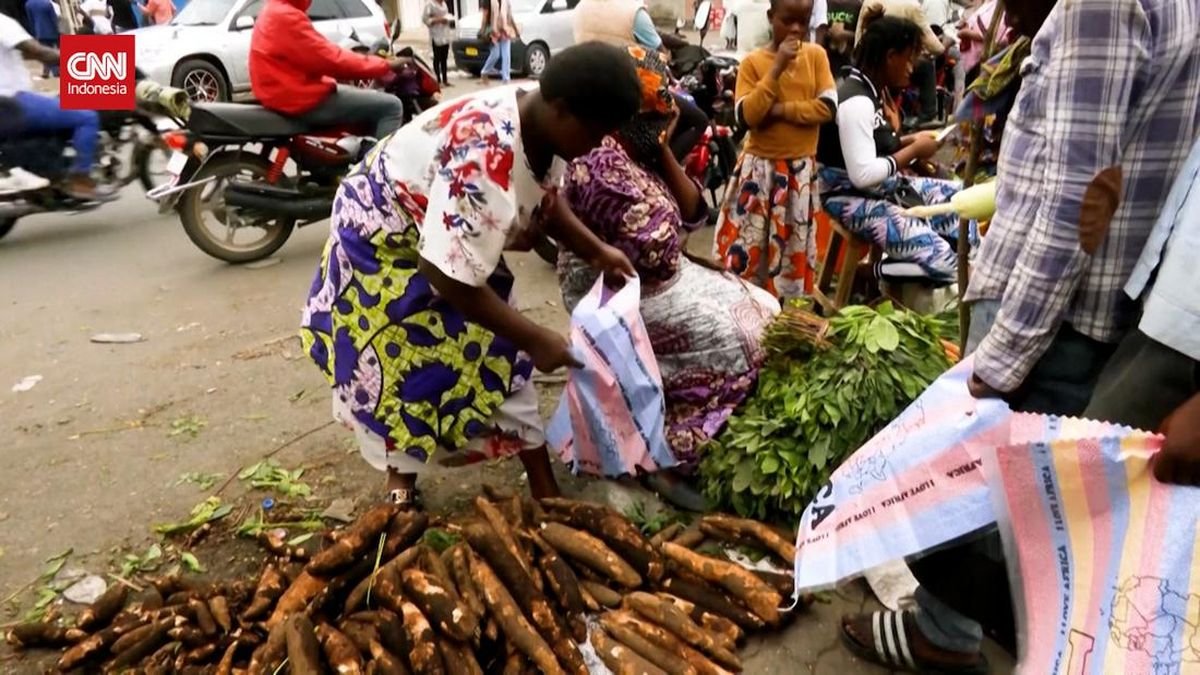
974,0,1150,392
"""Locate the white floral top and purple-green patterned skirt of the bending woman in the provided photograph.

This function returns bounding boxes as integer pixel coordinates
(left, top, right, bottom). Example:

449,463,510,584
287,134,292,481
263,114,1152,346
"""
301,88,556,471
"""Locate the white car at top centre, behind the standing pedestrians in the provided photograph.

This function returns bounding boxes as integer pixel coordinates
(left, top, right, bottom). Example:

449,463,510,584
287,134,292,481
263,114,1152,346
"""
451,0,580,78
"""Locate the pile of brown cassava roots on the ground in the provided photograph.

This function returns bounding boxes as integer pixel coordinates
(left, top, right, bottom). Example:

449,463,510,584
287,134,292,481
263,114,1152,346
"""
7,490,793,675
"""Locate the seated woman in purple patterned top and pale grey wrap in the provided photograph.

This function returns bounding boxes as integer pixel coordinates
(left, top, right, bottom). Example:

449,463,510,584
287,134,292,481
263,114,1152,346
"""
558,48,779,508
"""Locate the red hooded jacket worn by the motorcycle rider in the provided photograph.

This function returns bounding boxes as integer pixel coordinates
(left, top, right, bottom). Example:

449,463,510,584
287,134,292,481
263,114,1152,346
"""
250,0,391,115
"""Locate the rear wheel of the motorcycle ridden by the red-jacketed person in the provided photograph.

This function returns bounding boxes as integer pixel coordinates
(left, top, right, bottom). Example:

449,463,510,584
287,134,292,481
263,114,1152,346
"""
179,153,295,264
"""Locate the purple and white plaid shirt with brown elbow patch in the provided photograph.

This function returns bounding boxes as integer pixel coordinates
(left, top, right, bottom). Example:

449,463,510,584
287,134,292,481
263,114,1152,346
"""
966,0,1200,392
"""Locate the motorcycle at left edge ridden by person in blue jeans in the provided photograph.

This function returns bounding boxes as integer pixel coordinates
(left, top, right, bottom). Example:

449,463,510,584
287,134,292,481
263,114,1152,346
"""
0,97,177,238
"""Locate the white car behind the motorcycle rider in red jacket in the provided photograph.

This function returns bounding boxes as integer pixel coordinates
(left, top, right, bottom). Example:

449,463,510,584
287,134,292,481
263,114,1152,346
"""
132,0,388,101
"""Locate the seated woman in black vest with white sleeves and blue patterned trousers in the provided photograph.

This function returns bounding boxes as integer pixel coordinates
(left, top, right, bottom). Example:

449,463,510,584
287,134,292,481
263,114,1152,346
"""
817,13,959,281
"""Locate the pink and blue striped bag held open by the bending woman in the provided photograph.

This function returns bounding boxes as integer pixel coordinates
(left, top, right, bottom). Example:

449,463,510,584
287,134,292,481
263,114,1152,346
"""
546,277,679,477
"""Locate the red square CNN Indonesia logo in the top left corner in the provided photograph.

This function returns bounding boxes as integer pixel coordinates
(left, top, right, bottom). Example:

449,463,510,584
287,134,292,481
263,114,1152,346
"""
59,35,137,110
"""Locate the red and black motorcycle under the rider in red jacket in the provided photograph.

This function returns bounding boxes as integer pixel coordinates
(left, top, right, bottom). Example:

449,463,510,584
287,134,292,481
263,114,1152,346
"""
148,24,437,263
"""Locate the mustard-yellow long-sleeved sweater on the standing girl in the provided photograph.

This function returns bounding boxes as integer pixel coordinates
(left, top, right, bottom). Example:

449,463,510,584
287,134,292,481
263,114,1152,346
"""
734,42,838,160
